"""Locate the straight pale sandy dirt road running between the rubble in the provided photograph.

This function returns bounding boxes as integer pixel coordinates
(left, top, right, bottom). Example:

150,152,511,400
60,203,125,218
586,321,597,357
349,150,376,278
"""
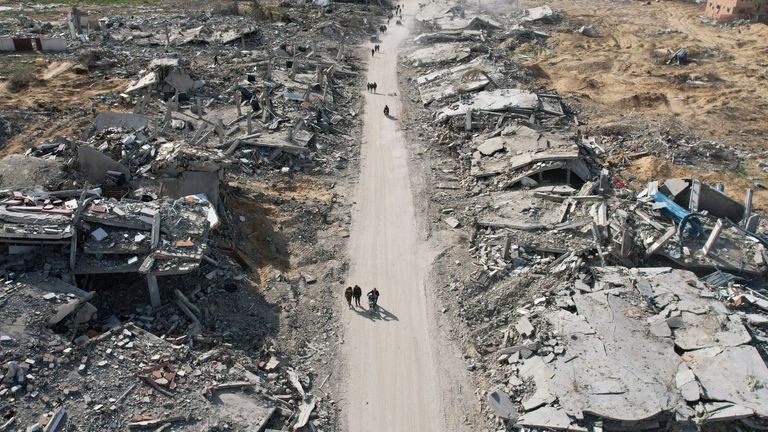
339,3,471,432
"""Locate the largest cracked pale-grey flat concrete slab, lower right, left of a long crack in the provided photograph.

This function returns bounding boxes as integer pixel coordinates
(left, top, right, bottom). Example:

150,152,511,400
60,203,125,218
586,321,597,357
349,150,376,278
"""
547,290,680,422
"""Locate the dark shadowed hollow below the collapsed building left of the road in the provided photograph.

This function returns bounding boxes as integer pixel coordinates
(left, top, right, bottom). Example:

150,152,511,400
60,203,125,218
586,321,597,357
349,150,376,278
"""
79,272,279,351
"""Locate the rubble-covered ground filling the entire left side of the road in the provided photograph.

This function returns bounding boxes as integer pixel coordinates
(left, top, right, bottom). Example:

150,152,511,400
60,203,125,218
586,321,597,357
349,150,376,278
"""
0,2,384,431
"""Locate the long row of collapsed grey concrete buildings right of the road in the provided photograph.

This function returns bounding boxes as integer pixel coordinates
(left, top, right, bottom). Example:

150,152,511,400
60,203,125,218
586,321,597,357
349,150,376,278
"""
402,3,768,431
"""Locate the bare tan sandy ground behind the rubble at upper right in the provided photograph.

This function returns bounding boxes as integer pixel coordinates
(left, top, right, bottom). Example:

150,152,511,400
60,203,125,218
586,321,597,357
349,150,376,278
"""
532,0,768,149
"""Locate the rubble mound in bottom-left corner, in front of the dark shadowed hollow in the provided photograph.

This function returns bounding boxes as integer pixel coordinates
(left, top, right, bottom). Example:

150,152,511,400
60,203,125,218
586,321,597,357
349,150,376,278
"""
0,278,314,430
